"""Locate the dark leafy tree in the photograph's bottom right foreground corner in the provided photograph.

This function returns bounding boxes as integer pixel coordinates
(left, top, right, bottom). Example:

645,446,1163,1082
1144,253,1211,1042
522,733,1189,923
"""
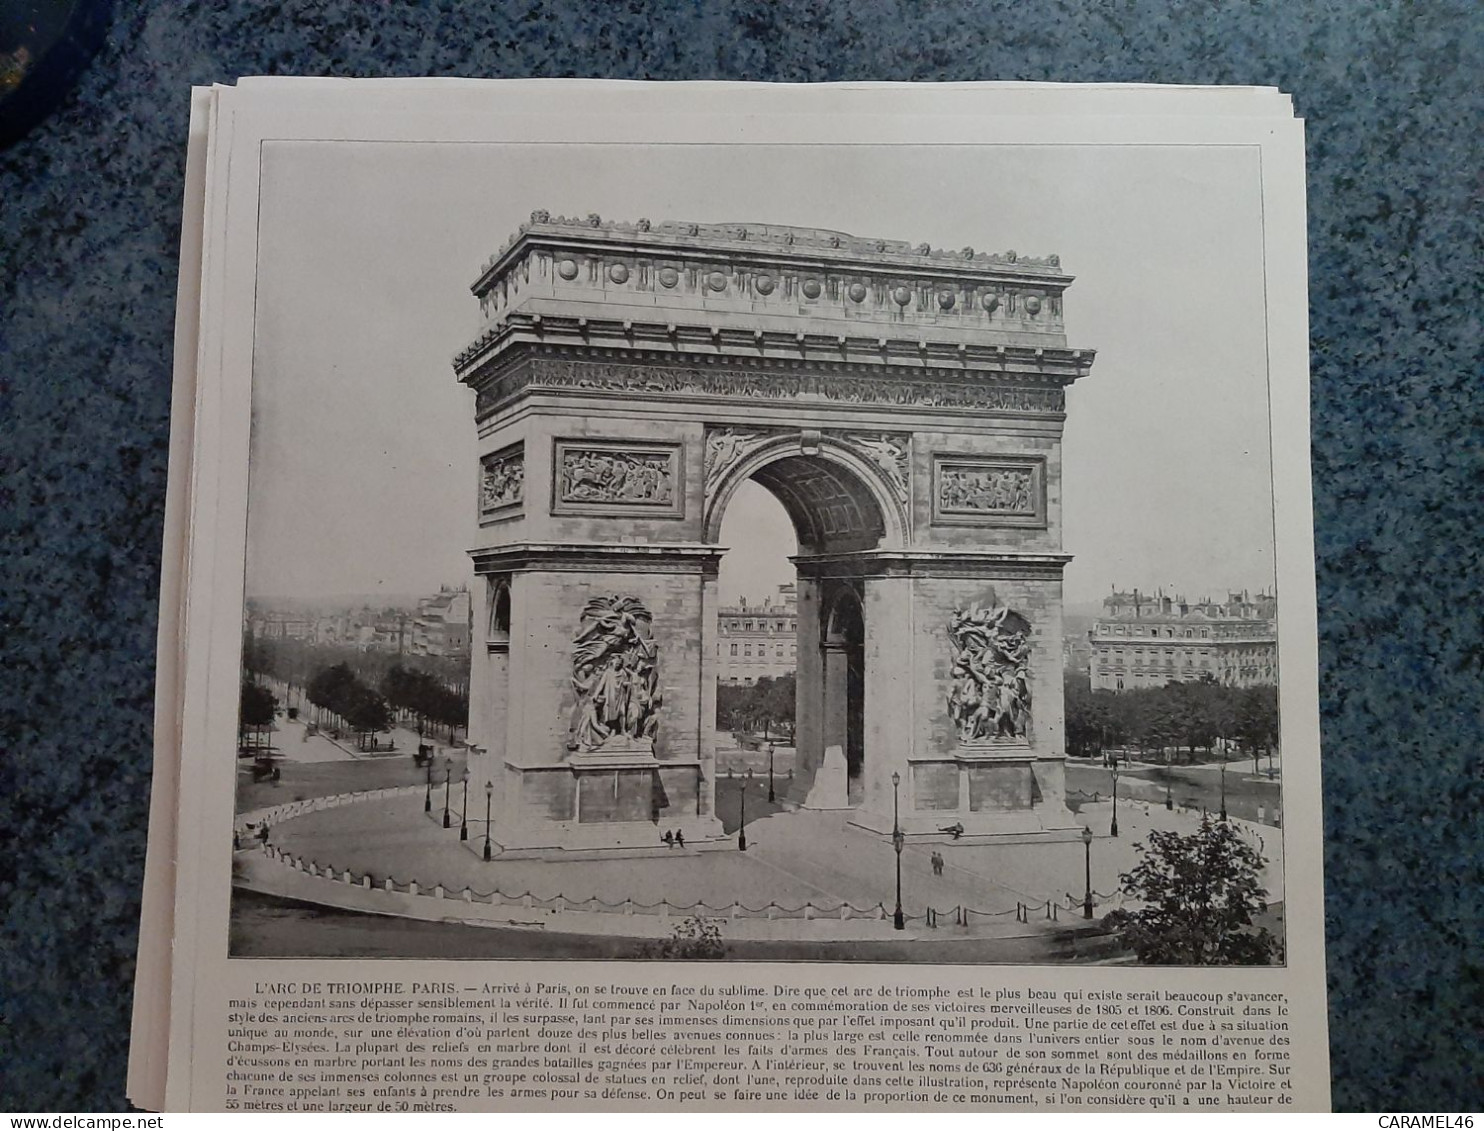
1104,816,1279,966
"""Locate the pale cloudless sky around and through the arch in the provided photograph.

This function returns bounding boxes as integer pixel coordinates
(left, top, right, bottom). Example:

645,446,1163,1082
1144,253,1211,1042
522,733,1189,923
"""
246,142,1273,617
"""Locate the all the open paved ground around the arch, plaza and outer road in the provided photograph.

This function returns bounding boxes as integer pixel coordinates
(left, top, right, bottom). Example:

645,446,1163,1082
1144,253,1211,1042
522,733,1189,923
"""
236,709,1282,962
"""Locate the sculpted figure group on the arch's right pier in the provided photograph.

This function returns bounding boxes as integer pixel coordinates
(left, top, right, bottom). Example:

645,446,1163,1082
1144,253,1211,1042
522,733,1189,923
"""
948,591,1031,745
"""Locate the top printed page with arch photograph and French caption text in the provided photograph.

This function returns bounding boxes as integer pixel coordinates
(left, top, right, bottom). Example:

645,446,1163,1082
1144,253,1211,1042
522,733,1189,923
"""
153,83,1328,1112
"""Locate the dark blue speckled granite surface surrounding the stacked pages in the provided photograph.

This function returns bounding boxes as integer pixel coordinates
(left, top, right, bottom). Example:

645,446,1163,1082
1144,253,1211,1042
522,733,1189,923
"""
0,0,1484,1110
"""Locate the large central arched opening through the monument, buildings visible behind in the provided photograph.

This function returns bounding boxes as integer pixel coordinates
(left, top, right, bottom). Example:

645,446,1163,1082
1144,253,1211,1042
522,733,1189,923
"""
708,447,890,825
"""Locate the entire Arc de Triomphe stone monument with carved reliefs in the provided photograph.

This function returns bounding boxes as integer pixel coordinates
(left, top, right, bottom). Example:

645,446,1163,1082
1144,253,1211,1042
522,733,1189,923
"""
454,212,1092,852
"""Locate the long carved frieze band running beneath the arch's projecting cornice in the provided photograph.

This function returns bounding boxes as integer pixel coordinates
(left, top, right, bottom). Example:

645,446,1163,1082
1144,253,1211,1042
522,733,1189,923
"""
476,358,1067,416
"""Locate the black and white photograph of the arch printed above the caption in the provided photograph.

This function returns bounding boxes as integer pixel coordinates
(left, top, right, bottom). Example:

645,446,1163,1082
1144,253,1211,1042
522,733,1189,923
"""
228,134,1288,966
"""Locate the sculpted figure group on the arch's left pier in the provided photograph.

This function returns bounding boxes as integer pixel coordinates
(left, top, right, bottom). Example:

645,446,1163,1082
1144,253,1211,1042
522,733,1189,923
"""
568,597,663,751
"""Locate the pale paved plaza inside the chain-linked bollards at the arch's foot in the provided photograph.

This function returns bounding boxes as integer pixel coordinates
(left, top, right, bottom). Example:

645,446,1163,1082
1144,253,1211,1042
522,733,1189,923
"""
249,787,1282,928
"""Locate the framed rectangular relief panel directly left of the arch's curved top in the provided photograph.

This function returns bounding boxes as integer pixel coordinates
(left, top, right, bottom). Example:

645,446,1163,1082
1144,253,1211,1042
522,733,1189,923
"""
552,439,684,517
